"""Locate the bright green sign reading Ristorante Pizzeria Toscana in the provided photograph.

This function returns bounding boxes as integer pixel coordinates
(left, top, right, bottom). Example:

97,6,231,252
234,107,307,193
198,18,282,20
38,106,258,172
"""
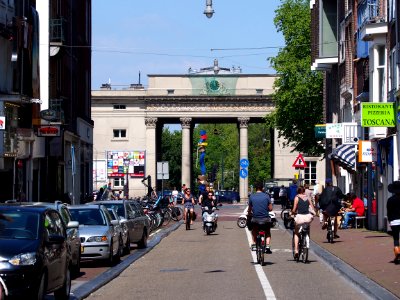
361,102,396,127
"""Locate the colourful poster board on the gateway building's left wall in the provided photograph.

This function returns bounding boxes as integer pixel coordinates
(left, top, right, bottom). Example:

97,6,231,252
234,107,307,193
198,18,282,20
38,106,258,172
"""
107,151,145,178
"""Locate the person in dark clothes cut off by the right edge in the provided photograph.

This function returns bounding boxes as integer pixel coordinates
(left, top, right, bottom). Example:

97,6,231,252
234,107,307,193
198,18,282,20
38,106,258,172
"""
386,181,400,263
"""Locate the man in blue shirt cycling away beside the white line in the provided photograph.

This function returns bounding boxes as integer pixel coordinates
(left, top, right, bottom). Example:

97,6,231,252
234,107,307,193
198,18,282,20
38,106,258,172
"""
247,183,272,254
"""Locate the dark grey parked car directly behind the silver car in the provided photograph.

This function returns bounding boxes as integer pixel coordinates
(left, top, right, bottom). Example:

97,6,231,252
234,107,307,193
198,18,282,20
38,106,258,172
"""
93,200,150,251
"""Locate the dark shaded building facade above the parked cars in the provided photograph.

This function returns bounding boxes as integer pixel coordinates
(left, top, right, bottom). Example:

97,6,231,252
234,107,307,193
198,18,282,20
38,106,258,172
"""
0,0,93,202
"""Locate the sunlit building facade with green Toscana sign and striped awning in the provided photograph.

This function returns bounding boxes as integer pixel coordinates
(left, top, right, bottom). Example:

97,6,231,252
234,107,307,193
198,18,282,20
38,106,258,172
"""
310,0,399,230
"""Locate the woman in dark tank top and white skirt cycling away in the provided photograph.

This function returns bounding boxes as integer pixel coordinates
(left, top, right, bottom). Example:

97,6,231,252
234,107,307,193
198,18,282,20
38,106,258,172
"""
292,186,315,259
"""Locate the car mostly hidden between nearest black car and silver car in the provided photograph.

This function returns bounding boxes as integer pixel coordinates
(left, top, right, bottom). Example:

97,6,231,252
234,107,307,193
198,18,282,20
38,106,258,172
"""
13,201,81,276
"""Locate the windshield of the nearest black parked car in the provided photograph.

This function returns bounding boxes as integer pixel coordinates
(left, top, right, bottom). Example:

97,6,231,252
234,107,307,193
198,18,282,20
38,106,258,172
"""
0,209,40,240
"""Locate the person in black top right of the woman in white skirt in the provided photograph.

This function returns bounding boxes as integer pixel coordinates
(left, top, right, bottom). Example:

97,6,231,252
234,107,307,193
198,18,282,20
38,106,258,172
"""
318,178,345,239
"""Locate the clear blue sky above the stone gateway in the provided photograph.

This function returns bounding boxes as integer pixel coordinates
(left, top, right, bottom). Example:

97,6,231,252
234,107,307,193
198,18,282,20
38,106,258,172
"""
92,0,284,90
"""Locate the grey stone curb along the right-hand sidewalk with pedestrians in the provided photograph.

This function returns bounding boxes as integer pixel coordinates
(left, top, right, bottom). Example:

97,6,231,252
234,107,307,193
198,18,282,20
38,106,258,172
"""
278,220,400,300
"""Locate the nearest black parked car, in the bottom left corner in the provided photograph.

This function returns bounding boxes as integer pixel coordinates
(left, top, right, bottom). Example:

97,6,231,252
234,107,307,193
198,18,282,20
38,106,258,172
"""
0,204,72,299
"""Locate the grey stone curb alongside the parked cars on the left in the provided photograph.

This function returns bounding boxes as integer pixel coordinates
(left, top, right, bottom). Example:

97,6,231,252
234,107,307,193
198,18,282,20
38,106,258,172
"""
69,221,182,300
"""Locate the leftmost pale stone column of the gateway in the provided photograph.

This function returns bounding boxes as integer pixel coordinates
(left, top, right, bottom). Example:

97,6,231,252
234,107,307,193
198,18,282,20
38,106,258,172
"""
144,118,157,186
